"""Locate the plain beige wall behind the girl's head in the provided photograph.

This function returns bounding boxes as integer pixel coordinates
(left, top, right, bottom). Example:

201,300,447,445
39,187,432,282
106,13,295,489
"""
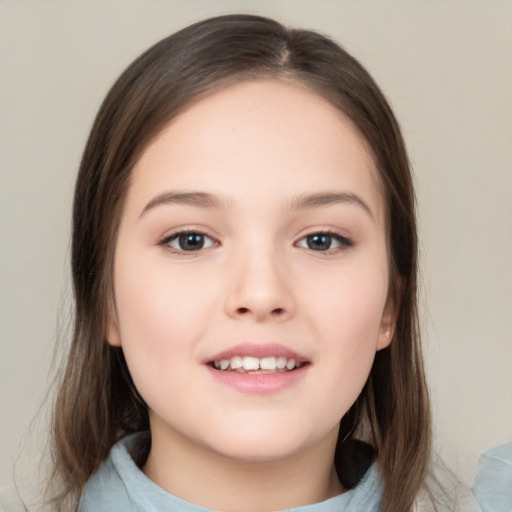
0,0,512,504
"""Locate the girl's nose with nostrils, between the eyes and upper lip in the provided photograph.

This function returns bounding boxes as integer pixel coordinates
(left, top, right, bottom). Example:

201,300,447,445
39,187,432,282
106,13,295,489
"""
226,246,295,322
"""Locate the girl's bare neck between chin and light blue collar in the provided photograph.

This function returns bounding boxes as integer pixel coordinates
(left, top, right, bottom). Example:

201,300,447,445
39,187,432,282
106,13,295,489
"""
143,422,343,512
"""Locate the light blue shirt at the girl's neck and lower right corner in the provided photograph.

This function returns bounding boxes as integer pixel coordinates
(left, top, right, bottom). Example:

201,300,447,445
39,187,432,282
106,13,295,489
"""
78,433,512,512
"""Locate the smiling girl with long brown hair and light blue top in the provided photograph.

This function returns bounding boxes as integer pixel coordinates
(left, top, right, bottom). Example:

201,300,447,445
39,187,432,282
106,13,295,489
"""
49,15,456,512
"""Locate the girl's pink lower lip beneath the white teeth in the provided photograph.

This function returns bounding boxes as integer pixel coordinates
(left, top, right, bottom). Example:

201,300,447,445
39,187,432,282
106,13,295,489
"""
206,364,310,395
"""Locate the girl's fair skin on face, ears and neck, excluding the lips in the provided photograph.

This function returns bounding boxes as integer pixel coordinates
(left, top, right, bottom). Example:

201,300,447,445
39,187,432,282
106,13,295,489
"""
108,80,393,512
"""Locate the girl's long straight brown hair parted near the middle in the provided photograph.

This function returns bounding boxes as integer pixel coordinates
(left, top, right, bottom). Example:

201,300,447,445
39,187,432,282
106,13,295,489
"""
51,15,431,512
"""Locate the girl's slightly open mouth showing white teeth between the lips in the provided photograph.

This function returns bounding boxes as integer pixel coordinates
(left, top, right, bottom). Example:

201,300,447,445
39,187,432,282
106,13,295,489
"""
208,355,309,375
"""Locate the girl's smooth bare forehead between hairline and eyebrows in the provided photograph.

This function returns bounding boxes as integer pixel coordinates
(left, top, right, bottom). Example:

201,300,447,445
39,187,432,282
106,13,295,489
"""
127,80,383,222
